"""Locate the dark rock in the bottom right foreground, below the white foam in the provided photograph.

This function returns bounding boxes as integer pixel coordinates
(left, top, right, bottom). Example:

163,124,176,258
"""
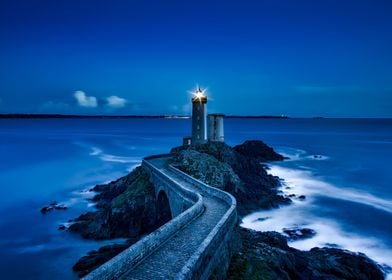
227,228,384,280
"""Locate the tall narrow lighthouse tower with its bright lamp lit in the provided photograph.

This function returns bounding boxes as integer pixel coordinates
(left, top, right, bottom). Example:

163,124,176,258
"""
192,87,207,145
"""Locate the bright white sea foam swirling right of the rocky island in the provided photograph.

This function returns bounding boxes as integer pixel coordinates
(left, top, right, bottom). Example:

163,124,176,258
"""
241,165,392,280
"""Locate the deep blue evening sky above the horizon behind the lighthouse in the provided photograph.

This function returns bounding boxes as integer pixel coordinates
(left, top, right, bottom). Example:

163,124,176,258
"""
0,0,392,117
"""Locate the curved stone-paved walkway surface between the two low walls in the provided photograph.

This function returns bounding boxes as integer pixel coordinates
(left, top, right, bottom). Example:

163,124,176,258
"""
120,158,229,280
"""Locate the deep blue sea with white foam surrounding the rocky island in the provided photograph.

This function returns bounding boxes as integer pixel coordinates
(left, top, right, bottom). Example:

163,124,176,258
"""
0,118,392,280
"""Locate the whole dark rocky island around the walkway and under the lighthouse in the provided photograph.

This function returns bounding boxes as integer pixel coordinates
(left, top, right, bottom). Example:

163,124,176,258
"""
68,141,384,279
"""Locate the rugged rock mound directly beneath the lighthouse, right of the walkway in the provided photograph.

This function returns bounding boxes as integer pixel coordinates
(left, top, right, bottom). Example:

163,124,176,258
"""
172,141,291,215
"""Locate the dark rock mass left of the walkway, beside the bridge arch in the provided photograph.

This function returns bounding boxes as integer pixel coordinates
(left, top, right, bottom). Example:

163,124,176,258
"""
69,167,156,239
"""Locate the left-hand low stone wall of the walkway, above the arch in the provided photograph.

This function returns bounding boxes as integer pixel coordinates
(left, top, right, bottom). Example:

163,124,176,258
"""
83,160,204,280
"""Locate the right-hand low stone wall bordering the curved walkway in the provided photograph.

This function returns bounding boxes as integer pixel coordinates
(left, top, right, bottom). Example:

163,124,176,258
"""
170,166,237,279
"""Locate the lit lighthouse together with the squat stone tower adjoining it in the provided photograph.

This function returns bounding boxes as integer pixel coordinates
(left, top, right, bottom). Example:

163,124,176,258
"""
183,87,224,146
